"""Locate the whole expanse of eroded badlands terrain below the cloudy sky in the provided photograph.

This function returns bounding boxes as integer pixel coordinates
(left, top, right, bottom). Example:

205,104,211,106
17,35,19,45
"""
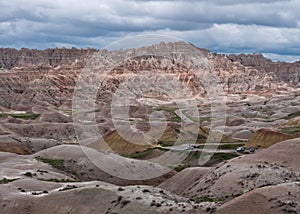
0,42,300,214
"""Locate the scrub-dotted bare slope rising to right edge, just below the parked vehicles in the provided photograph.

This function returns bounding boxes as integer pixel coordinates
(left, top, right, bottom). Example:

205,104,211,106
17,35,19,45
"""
182,138,300,202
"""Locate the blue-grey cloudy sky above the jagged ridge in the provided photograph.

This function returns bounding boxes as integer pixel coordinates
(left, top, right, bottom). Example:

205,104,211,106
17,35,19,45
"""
0,0,300,61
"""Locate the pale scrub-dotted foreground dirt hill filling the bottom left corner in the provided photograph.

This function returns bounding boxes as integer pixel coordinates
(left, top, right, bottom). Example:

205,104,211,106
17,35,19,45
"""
0,180,204,214
